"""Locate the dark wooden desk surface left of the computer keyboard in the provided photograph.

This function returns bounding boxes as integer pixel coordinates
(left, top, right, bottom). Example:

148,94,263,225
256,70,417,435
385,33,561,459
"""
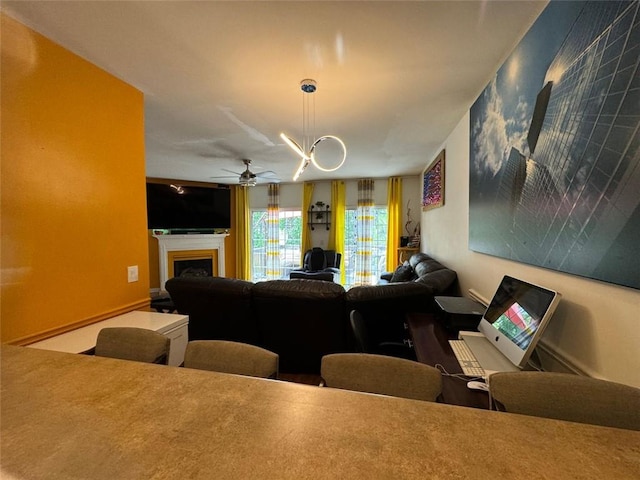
407,313,489,409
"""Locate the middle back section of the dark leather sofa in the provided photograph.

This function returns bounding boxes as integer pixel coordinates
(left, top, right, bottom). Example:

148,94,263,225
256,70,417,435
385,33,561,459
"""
251,279,349,373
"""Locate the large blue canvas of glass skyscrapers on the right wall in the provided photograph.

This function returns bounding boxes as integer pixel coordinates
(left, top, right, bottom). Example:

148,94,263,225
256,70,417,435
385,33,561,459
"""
469,1,640,289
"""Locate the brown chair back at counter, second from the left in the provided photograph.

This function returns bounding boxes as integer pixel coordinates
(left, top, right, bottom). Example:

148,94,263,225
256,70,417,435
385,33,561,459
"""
184,340,279,378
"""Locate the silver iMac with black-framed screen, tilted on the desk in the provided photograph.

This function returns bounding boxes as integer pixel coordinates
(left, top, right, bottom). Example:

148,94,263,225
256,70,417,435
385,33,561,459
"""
478,275,560,368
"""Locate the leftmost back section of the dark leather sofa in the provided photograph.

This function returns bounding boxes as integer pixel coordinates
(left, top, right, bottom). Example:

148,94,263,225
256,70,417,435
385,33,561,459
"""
165,277,258,345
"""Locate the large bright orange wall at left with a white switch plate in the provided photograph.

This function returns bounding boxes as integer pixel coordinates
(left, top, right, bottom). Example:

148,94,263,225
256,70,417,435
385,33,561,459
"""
0,14,149,343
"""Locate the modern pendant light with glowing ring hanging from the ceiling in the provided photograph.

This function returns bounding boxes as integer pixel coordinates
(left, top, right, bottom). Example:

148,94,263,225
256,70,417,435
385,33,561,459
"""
280,78,347,182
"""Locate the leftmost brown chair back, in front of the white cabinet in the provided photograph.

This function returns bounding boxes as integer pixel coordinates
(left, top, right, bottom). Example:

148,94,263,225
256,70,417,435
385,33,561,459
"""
95,327,171,365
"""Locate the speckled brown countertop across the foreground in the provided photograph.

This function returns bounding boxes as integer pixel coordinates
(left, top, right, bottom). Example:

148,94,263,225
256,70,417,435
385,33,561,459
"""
0,345,640,480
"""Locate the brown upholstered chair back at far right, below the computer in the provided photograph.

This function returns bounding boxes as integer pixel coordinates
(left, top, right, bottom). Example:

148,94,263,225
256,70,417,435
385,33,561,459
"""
489,372,640,430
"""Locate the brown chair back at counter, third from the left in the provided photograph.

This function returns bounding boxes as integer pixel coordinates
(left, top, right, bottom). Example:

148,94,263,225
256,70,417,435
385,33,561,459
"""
320,353,442,402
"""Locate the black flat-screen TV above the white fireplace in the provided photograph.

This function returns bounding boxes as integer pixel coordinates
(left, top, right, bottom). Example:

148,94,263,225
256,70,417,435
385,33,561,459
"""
147,182,231,233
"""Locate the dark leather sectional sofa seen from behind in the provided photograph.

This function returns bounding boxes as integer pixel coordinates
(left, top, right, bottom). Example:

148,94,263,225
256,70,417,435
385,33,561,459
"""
166,254,457,373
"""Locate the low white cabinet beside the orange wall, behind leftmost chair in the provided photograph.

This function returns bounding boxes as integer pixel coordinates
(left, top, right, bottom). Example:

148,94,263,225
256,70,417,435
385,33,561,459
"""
29,311,189,366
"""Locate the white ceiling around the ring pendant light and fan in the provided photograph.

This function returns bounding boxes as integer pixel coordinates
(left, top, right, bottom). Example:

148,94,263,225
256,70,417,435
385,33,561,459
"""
2,0,547,183
